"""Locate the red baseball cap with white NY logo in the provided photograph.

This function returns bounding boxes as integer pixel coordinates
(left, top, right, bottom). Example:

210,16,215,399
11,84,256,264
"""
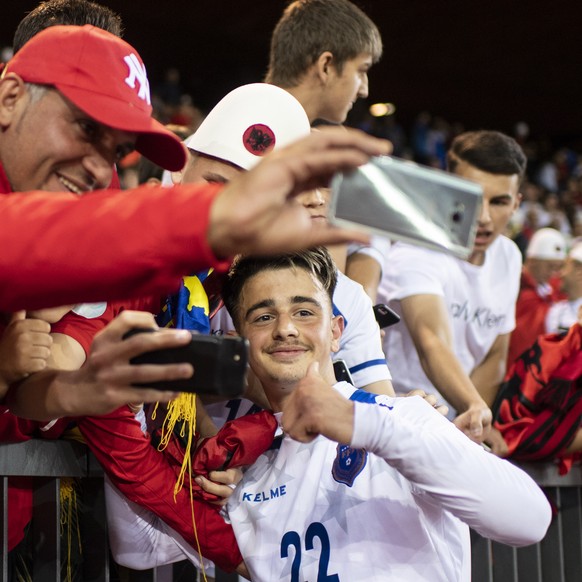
2,25,187,172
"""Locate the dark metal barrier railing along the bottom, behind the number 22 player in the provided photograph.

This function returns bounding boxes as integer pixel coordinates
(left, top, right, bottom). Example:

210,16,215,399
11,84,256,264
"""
0,440,582,582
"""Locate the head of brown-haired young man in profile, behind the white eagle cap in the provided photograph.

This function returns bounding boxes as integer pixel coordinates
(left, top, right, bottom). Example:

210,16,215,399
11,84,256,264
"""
265,0,382,123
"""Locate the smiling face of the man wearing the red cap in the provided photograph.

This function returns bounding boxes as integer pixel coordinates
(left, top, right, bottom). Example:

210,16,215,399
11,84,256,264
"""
0,79,137,195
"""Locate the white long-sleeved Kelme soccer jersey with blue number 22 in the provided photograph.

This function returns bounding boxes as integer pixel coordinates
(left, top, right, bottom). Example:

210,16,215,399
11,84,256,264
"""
227,383,550,582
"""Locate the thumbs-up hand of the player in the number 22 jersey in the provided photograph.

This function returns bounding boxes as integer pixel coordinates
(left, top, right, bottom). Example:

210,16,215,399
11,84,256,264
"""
281,362,354,444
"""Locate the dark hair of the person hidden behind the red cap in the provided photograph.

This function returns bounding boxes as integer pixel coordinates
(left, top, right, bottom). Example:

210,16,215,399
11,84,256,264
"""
12,0,123,53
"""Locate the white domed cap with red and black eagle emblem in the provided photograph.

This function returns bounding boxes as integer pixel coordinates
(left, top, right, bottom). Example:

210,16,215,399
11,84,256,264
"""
185,83,311,170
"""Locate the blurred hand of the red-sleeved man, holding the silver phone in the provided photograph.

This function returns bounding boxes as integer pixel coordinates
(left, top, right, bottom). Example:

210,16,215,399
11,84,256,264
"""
208,128,389,256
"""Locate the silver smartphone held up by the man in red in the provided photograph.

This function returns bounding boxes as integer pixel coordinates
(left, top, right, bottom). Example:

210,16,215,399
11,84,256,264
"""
330,156,483,259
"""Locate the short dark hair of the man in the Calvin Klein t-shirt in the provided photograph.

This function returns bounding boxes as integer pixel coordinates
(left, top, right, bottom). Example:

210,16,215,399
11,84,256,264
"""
447,130,527,180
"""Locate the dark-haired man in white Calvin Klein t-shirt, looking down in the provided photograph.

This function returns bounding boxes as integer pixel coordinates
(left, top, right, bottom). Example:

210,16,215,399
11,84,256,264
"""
381,131,526,446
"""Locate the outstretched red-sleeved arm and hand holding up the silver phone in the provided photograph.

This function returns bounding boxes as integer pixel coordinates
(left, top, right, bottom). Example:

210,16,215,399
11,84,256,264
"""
0,128,389,311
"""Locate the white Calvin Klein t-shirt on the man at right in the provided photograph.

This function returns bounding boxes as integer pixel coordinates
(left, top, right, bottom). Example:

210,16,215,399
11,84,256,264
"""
378,236,521,408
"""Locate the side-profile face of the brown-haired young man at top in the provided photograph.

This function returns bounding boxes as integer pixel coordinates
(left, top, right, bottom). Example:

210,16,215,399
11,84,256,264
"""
319,53,373,123
